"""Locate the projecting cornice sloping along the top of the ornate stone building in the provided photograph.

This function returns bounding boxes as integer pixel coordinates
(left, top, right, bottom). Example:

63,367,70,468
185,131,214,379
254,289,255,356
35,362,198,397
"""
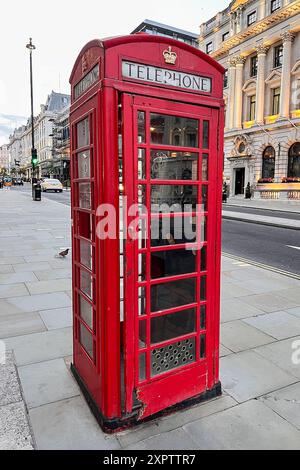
210,0,300,60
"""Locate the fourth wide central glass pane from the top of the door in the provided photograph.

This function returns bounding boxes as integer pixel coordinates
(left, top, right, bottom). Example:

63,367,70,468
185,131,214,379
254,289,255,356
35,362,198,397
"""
151,216,197,246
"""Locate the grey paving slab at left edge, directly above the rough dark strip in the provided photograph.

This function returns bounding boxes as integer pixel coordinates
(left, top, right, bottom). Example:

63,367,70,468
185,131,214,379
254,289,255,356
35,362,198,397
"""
0,310,46,338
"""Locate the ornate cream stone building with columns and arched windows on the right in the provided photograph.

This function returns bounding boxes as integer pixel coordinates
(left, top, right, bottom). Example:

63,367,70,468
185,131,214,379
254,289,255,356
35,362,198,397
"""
199,0,300,199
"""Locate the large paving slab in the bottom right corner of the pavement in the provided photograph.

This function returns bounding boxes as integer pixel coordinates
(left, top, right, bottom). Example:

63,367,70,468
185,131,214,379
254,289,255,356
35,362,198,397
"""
183,400,300,450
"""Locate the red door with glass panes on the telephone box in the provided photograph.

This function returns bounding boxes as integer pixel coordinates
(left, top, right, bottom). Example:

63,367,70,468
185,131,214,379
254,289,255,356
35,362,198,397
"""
122,94,221,419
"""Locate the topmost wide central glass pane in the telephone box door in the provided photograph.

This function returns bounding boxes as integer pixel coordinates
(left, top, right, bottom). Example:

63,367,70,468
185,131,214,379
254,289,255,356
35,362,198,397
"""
150,113,199,147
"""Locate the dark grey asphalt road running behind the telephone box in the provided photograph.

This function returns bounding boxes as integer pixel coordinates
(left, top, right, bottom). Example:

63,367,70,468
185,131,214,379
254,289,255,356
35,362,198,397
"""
12,185,300,274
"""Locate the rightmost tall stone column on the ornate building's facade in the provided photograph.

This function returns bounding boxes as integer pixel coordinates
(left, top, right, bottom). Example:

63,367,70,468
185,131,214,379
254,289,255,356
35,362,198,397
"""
280,31,295,118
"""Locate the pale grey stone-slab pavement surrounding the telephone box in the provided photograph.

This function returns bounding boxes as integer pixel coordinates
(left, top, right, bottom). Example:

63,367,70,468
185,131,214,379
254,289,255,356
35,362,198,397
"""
0,191,300,450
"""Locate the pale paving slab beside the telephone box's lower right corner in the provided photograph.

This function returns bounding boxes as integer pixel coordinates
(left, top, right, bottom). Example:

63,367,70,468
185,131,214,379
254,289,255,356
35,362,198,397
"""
221,351,297,403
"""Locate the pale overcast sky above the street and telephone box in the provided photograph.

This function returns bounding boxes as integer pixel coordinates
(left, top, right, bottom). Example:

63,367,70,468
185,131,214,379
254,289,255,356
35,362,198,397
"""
0,0,229,145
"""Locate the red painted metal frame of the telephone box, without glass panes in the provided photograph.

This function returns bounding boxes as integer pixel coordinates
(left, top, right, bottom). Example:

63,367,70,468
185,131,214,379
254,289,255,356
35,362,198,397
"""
70,34,224,422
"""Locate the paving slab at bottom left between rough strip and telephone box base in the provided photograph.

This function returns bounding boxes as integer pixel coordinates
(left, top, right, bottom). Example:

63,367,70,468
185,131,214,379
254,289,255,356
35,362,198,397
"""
29,396,121,450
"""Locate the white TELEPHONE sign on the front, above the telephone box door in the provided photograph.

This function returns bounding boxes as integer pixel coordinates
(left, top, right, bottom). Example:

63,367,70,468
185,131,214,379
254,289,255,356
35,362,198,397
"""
122,61,212,93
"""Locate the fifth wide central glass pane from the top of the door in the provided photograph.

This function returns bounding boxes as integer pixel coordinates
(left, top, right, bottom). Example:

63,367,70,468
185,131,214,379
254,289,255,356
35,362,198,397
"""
151,250,197,279
